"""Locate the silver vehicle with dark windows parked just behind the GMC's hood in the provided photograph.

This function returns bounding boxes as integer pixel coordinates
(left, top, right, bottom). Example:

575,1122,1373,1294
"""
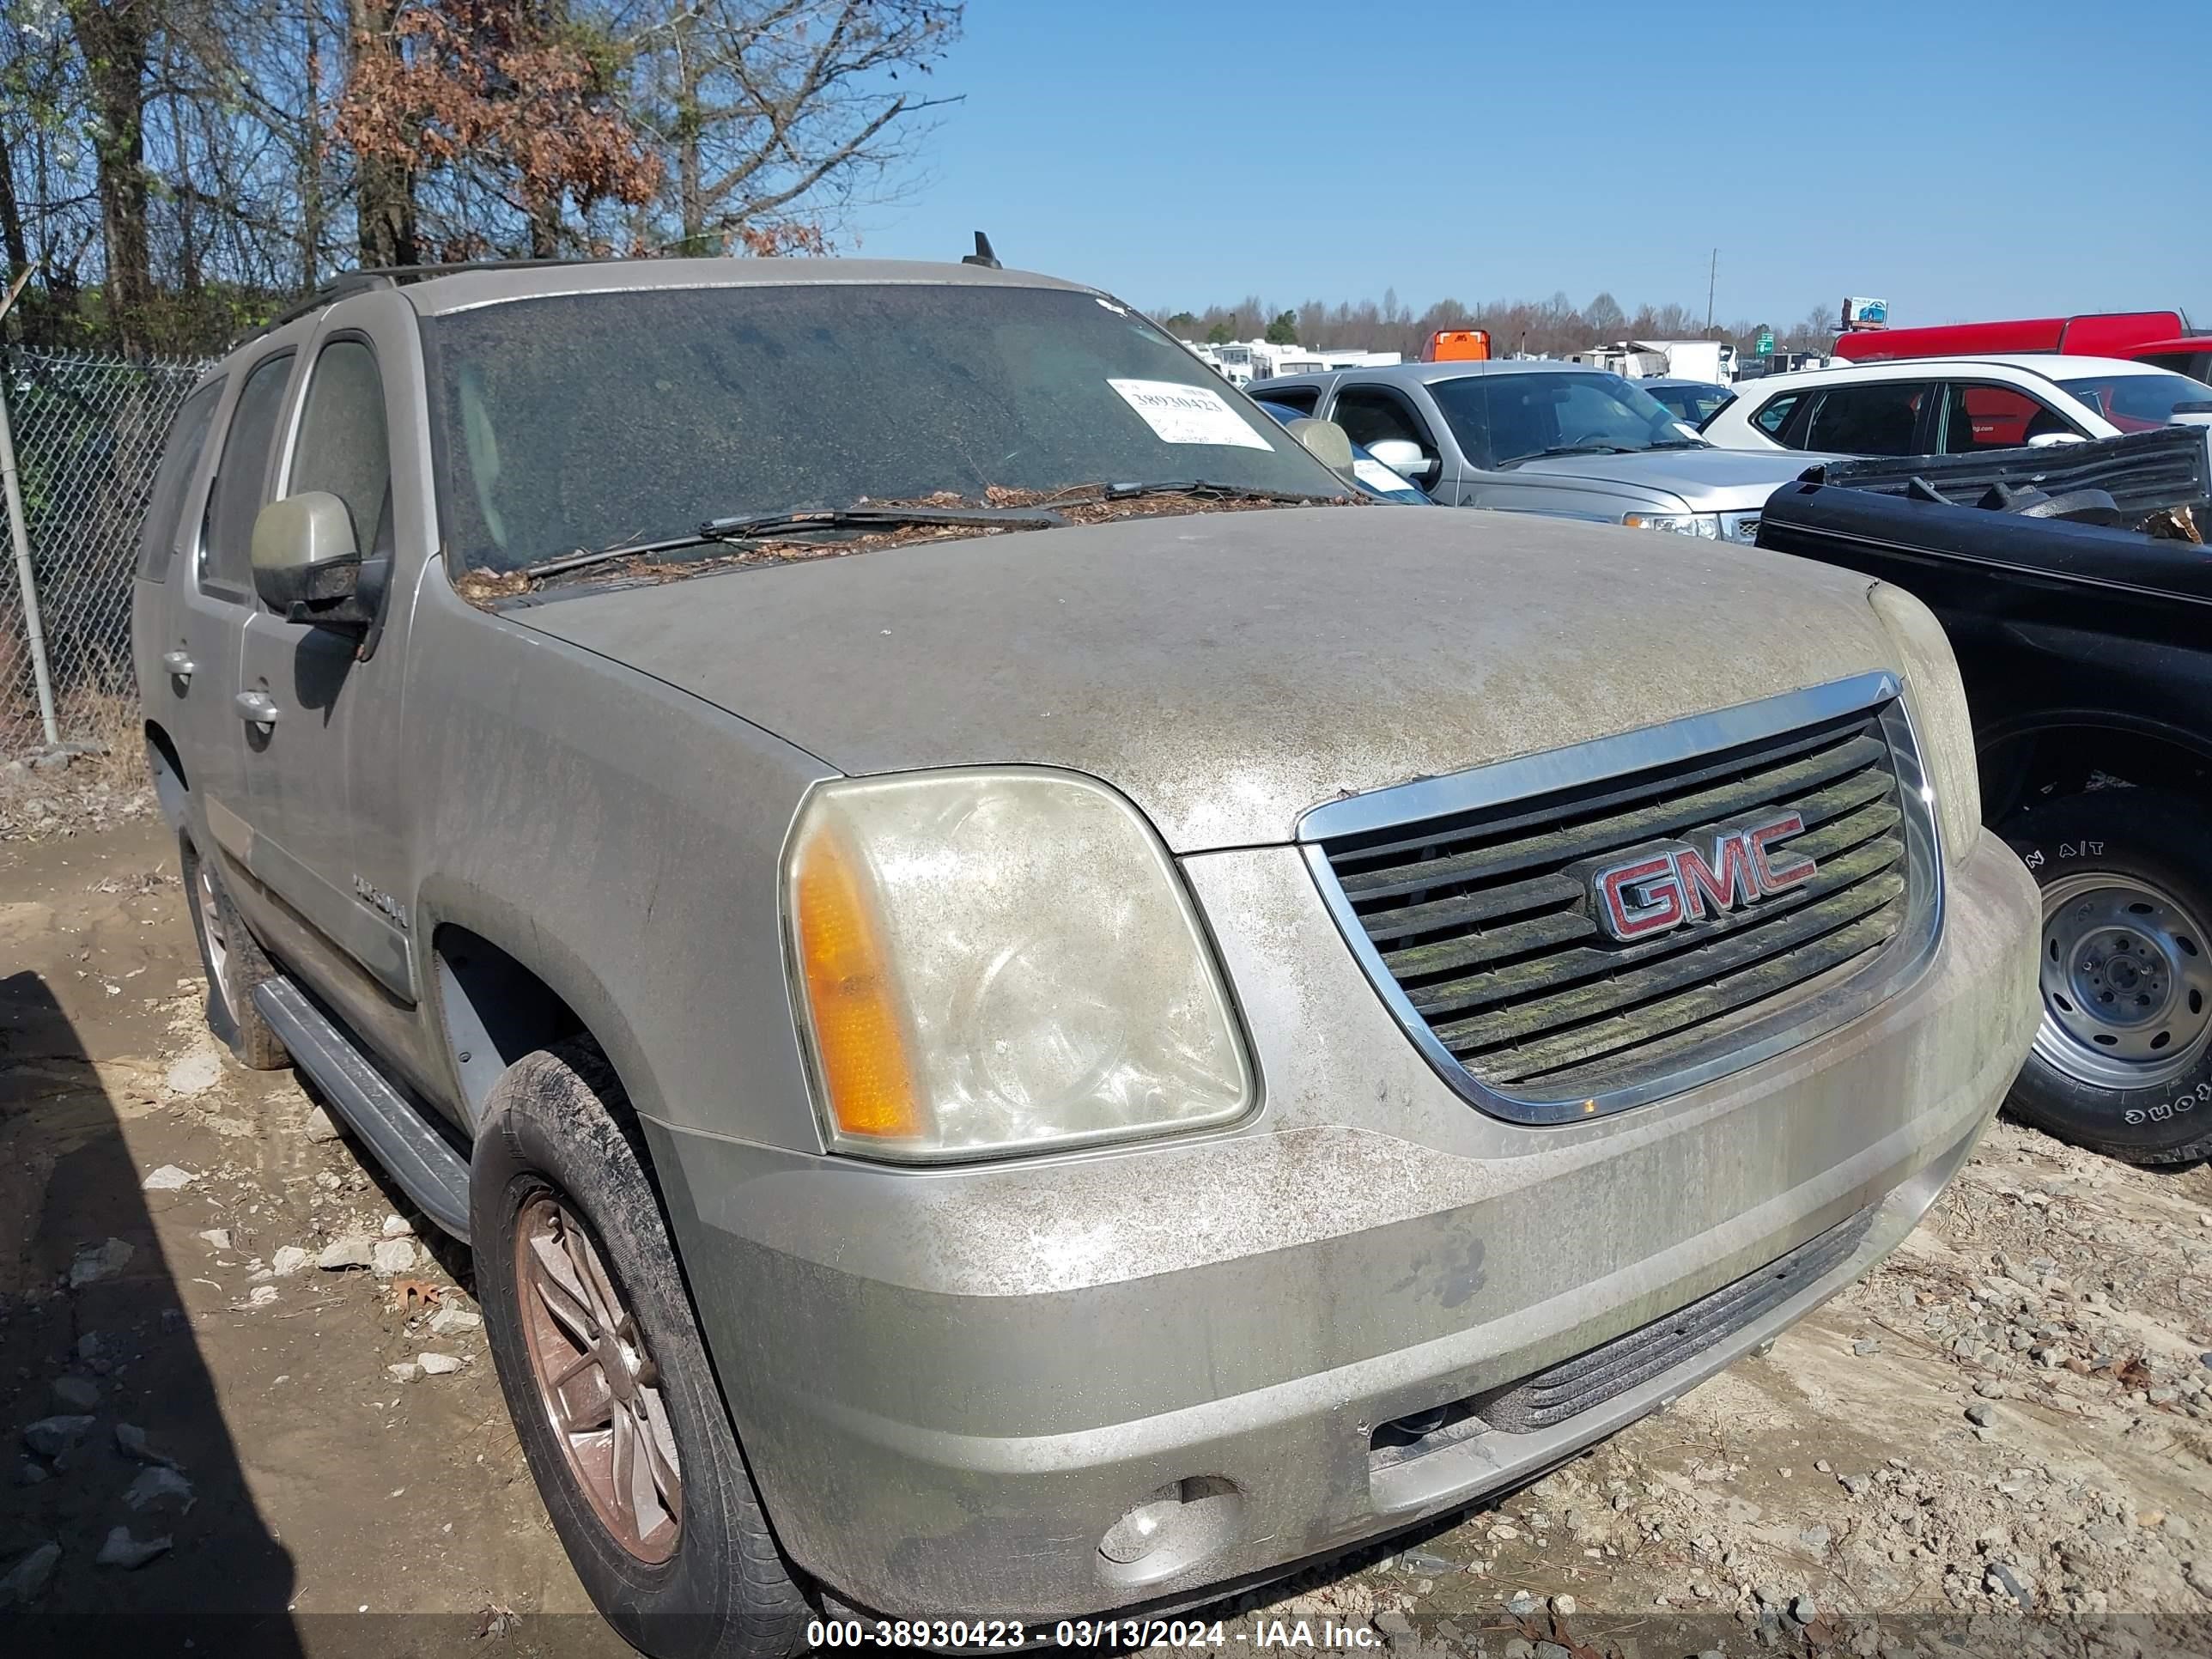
1245,361,1820,542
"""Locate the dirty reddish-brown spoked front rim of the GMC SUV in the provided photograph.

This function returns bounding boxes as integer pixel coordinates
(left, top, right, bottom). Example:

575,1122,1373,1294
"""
515,1194,684,1564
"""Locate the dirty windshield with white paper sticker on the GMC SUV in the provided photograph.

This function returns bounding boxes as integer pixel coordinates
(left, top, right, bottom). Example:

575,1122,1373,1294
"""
434,283,1345,573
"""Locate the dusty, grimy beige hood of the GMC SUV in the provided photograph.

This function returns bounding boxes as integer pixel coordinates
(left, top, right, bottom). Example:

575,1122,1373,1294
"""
507,507,1889,852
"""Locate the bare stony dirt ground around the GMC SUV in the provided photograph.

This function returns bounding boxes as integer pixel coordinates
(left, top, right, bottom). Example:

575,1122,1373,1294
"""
0,823,2212,1659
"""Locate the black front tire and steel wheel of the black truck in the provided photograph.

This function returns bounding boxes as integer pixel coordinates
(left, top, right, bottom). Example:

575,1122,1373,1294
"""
2000,787,2212,1164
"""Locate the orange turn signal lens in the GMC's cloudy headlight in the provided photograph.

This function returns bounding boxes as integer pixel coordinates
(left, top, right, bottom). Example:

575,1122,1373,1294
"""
792,825,922,1141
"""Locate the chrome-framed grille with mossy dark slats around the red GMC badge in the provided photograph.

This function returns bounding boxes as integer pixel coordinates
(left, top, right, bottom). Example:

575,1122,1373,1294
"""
1307,677,1940,1121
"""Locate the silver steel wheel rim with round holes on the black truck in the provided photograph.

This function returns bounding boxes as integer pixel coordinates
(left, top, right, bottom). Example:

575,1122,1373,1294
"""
2035,869,2212,1088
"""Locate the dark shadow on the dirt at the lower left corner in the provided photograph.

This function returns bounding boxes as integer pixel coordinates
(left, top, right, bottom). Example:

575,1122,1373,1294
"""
0,971,301,1655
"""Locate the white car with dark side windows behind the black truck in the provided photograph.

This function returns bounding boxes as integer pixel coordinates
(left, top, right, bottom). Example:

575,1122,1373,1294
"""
1701,354,2212,456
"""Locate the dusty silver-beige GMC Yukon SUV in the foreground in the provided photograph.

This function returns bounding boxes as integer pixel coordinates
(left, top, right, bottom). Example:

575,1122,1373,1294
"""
135,261,2037,1655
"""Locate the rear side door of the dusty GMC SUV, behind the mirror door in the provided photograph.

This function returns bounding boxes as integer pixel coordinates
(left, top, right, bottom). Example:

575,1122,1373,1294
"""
161,347,296,871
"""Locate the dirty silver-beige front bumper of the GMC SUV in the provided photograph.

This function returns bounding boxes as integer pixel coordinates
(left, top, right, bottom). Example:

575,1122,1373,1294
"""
648,836,2037,1620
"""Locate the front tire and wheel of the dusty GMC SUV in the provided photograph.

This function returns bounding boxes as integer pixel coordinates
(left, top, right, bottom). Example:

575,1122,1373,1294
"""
469,1040,811,1659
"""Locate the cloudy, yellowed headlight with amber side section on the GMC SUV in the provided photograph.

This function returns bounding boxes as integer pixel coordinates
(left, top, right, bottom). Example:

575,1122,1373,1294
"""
783,768,1255,1161
